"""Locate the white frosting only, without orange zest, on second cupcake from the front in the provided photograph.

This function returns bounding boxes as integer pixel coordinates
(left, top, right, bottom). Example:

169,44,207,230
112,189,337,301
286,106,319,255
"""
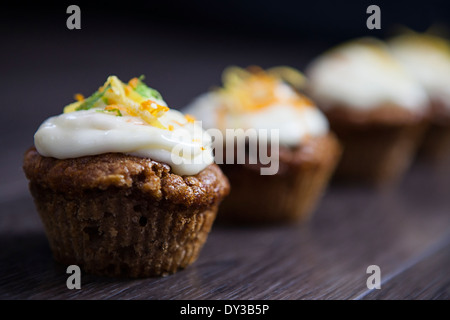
183,68,329,146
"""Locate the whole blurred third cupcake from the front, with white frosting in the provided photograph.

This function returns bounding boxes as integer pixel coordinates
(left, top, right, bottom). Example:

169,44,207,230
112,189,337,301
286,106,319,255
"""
306,38,428,187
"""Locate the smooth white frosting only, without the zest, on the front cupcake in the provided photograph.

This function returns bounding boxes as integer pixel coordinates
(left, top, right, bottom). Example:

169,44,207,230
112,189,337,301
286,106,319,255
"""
34,76,214,175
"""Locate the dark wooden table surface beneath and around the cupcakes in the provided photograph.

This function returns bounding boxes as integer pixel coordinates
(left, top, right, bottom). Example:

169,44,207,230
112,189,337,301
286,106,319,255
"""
0,165,450,300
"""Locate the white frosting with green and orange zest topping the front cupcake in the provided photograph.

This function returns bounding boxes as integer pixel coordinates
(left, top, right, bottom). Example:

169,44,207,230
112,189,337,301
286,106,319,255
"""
34,76,213,175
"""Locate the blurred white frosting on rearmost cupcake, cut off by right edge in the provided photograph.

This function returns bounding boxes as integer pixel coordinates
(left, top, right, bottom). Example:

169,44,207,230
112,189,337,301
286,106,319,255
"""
389,32,450,112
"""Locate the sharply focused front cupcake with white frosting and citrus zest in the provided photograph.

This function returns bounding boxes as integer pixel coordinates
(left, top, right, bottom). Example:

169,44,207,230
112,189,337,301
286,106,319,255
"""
23,76,229,277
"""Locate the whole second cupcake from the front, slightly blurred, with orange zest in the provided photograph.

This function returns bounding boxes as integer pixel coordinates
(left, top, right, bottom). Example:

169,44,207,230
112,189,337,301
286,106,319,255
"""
185,67,341,224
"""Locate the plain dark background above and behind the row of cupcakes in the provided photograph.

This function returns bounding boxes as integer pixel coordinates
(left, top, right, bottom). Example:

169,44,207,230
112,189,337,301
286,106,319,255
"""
0,0,450,186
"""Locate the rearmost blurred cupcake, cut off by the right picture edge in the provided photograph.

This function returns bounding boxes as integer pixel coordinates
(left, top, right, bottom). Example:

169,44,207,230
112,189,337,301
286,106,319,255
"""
388,32,450,166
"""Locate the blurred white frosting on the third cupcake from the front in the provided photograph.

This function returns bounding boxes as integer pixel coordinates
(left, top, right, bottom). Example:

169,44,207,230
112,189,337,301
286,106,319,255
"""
306,38,428,113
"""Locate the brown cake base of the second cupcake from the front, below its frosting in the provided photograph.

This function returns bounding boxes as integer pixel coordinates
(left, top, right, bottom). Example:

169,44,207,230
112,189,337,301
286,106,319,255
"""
217,137,341,224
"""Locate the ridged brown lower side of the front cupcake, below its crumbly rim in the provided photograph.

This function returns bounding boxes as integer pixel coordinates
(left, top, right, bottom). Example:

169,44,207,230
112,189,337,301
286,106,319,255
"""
30,183,217,278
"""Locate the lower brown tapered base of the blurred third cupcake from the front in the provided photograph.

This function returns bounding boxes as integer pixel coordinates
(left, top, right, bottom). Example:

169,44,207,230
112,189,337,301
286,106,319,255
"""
332,122,427,187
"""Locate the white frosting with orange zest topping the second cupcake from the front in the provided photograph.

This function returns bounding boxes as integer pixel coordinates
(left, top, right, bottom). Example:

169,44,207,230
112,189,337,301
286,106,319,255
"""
185,67,329,146
